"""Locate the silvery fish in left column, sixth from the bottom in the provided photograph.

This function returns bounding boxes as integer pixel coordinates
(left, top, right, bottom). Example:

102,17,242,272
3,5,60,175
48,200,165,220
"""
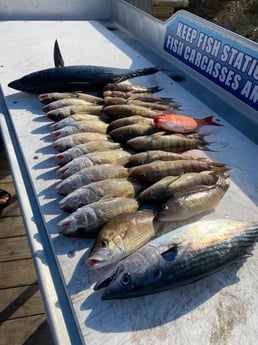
52,132,109,152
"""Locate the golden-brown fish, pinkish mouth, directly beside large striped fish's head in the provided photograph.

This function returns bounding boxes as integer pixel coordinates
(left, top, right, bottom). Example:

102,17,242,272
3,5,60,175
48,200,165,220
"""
86,211,161,269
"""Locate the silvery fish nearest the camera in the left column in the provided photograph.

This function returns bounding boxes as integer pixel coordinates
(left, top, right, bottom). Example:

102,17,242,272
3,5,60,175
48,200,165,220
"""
58,198,138,237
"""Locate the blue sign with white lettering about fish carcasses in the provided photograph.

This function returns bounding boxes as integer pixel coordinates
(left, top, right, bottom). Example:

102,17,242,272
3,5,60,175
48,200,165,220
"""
164,18,258,110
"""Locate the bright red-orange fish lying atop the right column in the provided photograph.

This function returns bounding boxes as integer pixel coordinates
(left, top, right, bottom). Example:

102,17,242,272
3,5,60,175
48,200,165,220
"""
154,114,223,133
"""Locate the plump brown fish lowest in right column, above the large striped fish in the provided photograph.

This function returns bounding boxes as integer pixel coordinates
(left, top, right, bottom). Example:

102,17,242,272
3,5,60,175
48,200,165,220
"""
156,177,229,222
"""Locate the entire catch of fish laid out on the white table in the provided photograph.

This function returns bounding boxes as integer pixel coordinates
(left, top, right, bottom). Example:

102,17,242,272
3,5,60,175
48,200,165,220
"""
9,42,255,299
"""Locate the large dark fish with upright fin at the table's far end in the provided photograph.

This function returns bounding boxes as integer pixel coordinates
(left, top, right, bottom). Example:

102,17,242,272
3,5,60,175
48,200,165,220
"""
8,41,159,93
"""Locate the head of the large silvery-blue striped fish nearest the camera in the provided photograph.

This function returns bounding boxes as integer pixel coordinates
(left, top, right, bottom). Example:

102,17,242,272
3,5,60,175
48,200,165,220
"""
94,248,161,300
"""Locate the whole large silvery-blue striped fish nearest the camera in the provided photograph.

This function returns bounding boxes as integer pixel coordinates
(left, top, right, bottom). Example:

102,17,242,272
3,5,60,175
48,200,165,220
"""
94,219,258,299
